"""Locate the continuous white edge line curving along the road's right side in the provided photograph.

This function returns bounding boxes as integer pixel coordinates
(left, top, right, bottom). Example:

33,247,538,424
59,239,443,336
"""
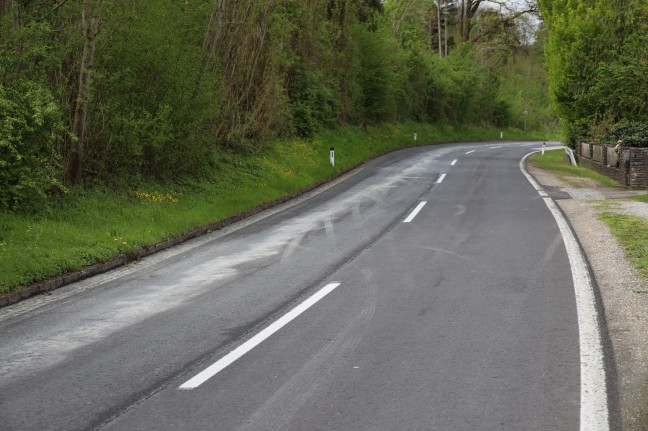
520,151,610,431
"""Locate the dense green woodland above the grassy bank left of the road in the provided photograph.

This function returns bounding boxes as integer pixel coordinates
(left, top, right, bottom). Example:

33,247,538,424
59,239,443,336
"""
0,0,556,214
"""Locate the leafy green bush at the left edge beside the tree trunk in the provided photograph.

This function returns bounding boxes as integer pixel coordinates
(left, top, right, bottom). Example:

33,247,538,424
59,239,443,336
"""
0,82,64,212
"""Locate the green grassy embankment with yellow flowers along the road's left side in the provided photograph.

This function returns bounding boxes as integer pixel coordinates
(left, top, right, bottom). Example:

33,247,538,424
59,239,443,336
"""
0,123,556,294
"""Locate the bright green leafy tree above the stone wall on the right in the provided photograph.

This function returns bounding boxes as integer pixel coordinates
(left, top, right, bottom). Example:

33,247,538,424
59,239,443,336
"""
539,0,648,143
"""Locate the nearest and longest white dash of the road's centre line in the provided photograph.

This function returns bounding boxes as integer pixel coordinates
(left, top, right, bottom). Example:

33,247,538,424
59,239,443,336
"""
178,283,340,390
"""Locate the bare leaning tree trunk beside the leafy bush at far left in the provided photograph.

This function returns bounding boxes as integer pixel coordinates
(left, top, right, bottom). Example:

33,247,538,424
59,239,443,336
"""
65,0,102,185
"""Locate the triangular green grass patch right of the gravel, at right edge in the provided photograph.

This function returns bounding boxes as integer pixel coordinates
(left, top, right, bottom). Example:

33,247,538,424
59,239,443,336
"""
599,212,648,280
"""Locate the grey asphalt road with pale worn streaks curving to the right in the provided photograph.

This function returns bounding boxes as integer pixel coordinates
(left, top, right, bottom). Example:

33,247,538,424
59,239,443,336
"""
0,143,604,431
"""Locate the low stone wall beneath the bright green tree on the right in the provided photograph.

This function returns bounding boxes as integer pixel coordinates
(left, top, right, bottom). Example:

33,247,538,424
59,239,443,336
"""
576,142,648,189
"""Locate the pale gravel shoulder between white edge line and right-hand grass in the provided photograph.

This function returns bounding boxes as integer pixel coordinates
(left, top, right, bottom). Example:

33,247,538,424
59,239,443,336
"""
527,165,648,431
